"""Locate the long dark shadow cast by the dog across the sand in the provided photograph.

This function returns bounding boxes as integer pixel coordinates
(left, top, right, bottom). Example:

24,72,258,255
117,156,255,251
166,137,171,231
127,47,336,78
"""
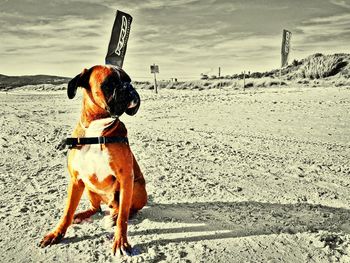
129,201,350,246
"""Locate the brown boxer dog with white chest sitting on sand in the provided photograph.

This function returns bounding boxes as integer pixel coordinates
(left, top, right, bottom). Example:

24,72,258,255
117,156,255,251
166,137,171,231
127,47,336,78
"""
40,66,147,255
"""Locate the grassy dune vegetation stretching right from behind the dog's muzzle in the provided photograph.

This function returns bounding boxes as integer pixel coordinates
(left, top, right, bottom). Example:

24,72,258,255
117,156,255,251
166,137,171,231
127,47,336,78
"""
134,53,350,90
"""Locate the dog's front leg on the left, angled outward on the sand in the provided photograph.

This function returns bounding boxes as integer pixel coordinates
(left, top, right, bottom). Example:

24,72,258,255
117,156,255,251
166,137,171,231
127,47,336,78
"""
39,178,85,247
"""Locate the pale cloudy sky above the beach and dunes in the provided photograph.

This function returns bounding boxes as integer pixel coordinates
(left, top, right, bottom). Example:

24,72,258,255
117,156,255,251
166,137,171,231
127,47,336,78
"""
0,0,350,80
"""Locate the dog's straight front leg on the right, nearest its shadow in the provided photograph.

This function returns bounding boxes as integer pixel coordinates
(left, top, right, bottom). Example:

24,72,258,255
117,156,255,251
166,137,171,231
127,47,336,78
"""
112,171,134,256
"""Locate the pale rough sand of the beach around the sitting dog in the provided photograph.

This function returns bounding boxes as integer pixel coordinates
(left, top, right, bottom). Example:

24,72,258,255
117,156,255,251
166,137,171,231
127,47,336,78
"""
0,87,350,262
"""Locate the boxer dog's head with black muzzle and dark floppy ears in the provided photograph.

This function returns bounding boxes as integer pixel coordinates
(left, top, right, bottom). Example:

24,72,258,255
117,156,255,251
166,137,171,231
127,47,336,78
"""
67,66,141,117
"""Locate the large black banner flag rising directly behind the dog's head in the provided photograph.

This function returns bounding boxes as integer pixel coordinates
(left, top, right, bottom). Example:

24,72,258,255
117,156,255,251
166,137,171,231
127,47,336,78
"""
105,10,132,67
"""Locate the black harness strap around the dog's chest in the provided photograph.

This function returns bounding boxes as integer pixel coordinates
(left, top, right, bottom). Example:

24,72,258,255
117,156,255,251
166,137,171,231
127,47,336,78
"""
57,136,129,149
